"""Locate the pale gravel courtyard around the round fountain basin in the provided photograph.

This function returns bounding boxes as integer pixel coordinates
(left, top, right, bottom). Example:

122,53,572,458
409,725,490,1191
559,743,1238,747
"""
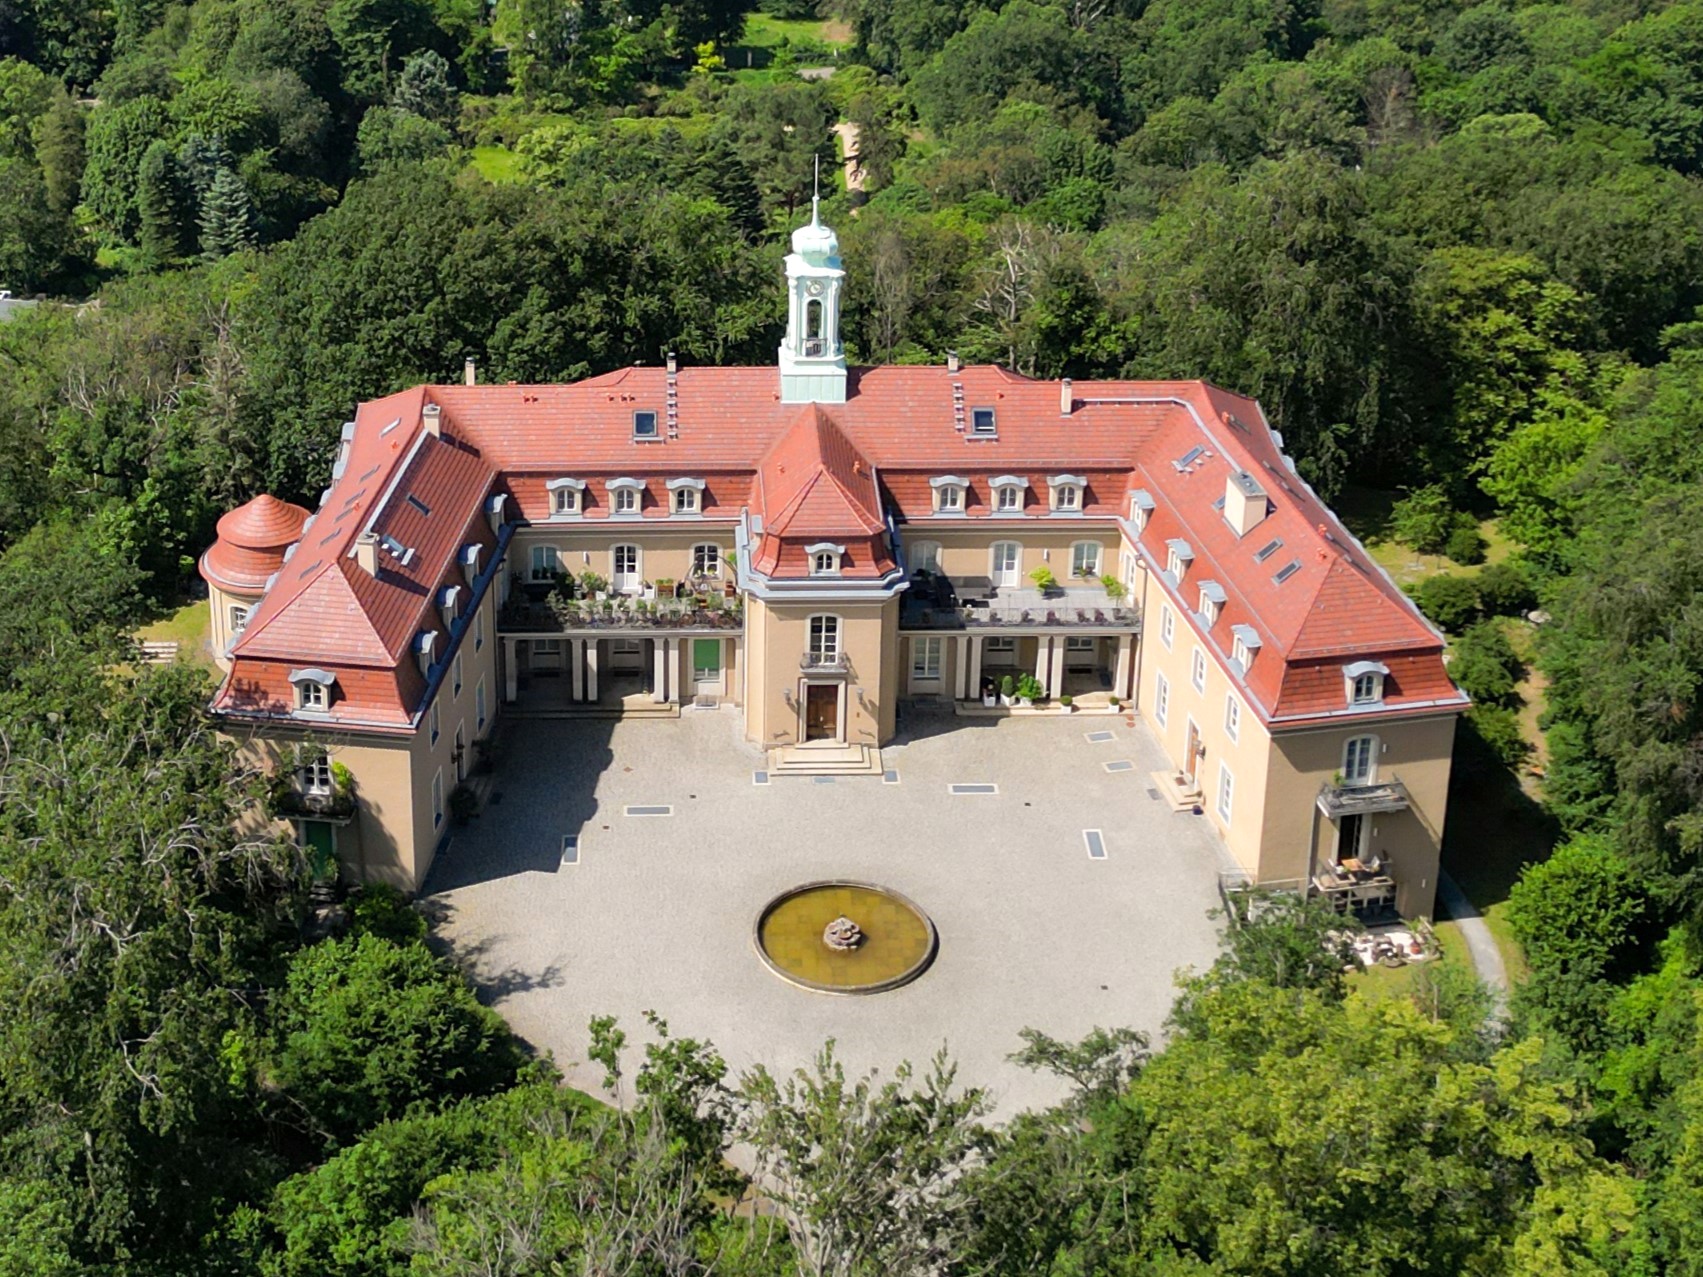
422,710,1223,1117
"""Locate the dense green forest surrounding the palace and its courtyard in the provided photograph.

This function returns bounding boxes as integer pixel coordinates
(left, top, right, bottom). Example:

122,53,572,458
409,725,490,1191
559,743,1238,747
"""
0,0,1703,1277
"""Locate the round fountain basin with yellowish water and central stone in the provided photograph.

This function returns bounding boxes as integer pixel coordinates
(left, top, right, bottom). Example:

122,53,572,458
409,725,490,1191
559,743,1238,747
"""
751,882,938,993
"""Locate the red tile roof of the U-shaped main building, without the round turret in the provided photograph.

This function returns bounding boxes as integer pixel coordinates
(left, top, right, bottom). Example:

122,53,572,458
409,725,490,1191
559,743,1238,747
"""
209,366,1461,735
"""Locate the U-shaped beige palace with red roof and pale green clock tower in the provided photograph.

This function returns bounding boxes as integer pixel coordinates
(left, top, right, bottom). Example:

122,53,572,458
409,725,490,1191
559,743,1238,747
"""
201,200,1466,914
